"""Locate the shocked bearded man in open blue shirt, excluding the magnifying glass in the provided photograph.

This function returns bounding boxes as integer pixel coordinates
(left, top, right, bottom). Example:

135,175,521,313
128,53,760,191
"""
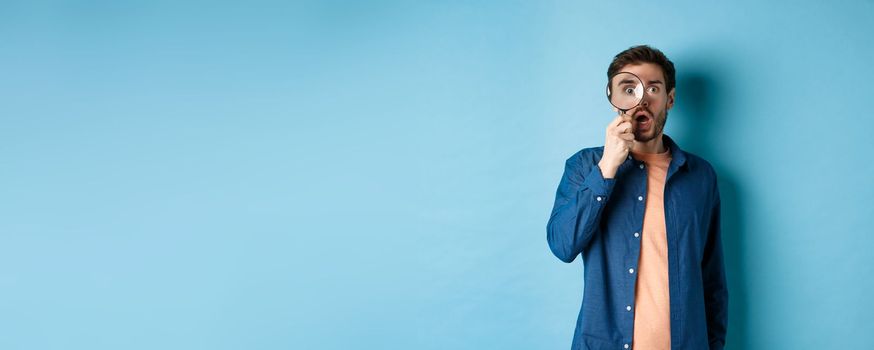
546,46,728,350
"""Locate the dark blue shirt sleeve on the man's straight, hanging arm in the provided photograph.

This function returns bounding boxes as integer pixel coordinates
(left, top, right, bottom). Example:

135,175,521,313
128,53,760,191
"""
701,179,728,350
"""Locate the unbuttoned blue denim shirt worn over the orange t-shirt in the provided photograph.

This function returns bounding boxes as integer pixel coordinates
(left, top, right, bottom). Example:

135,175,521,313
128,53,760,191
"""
546,135,728,350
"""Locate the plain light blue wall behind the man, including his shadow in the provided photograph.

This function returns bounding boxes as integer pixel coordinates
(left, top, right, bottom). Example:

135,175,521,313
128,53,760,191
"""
0,0,874,349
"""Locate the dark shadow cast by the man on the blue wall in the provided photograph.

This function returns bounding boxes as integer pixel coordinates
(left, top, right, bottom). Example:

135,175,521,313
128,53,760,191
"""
668,66,752,350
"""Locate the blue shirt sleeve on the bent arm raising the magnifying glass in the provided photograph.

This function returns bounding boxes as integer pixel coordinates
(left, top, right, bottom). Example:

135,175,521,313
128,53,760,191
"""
546,153,616,263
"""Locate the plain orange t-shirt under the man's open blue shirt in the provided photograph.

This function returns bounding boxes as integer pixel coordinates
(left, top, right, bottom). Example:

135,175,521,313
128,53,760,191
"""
632,150,671,350
